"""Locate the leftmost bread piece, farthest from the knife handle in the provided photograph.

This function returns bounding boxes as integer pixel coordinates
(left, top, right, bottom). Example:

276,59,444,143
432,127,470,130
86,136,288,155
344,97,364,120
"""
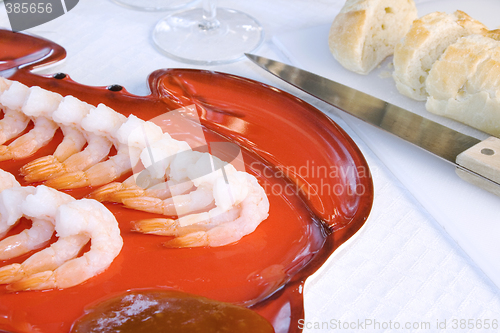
328,0,417,74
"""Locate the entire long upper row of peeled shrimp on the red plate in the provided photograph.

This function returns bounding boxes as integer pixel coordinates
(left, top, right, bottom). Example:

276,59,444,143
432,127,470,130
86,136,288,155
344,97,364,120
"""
0,78,269,247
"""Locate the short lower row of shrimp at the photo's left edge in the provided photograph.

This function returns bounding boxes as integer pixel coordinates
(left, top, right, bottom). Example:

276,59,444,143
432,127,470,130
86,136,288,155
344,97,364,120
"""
0,170,123,291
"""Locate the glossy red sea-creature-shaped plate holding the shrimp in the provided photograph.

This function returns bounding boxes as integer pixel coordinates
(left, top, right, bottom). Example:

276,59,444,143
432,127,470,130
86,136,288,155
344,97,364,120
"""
0,30,373,333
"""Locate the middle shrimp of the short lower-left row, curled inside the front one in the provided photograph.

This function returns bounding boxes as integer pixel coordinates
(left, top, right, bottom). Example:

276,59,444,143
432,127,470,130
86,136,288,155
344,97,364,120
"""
0,185,75,260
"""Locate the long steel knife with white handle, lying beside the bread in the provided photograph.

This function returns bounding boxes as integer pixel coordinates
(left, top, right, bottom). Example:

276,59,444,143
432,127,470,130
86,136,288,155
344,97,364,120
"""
245,54,500,196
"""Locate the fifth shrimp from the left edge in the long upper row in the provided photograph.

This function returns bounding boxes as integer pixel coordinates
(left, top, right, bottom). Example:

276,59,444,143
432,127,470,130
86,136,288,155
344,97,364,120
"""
46,115,162,189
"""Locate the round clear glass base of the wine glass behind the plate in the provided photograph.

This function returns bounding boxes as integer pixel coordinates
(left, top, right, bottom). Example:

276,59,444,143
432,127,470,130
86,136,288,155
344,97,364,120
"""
153,0,264,65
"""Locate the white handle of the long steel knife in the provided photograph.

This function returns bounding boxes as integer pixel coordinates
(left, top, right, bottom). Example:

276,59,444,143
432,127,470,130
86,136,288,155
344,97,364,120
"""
456,137,500,196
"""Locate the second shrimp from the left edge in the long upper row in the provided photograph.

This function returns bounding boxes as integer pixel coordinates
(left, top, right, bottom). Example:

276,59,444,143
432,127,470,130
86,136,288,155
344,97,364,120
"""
0,85,62,161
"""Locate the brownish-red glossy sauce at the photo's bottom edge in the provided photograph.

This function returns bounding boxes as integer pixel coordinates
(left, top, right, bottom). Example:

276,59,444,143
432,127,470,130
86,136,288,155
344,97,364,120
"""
71,290,274,333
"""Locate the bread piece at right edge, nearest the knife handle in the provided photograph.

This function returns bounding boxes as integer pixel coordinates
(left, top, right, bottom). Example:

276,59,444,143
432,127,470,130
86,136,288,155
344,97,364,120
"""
426,32,500,137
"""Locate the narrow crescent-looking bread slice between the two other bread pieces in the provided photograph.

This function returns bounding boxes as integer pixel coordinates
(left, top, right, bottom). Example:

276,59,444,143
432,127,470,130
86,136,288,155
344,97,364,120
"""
393,10,487,101
